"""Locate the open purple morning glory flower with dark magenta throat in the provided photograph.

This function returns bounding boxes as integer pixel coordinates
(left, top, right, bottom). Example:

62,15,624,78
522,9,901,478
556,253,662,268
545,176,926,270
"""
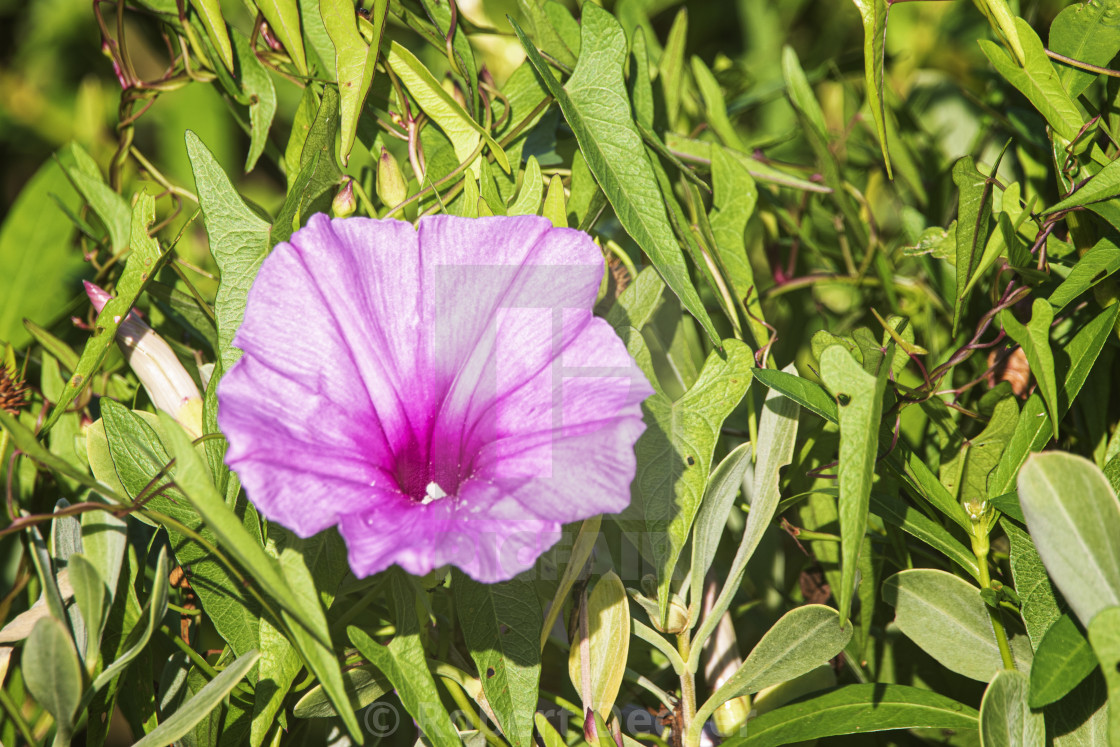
218,215,652,581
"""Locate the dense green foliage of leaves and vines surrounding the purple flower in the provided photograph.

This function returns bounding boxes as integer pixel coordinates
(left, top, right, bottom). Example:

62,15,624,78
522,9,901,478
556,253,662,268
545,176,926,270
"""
0,0,1120,747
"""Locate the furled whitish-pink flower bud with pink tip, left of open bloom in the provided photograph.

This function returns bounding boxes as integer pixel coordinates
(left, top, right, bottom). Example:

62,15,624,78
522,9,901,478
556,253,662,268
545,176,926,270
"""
83,281,203,438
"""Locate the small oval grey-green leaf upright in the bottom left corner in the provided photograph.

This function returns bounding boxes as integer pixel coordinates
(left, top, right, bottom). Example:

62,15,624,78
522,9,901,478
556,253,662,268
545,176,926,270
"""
19,617,83,744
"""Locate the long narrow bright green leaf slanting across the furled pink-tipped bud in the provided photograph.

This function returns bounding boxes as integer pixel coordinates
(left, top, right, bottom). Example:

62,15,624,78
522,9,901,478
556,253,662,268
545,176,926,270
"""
39,193,166,436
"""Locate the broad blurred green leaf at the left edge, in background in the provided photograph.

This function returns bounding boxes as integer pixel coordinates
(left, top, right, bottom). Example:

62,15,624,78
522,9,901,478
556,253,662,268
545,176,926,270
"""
0,151,87,347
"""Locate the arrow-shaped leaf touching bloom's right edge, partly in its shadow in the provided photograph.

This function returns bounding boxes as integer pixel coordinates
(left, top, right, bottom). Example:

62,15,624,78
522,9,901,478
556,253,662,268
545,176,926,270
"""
622,334,754,620
